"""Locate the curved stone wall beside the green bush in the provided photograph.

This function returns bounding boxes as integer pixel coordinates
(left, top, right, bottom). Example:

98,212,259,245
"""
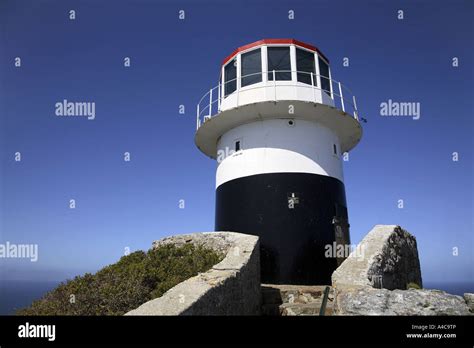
125,232,261,315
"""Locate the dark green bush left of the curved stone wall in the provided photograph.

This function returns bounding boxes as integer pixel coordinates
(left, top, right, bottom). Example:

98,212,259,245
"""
16,244,222,315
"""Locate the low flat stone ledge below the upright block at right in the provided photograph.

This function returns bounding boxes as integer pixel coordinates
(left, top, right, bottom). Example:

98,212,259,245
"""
334,287,470,315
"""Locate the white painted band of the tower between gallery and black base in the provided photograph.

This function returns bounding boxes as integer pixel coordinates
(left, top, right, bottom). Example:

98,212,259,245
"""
216,119,344,187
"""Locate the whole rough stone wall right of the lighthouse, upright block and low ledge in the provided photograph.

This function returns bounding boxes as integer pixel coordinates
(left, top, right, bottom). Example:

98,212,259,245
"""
332,225,472,315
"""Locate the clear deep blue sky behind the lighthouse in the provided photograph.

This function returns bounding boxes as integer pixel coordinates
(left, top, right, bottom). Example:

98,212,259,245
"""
0,0,474,282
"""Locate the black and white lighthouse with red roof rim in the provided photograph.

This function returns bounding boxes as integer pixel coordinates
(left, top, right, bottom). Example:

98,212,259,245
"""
195,39,362,284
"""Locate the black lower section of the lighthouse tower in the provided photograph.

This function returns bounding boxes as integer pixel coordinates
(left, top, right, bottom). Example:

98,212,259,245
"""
215,173,350,284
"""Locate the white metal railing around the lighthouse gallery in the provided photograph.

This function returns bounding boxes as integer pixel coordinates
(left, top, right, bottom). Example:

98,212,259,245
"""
196,70,359,128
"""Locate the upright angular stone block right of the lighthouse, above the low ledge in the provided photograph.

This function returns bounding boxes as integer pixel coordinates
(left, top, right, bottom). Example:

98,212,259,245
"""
332,225,422,290
